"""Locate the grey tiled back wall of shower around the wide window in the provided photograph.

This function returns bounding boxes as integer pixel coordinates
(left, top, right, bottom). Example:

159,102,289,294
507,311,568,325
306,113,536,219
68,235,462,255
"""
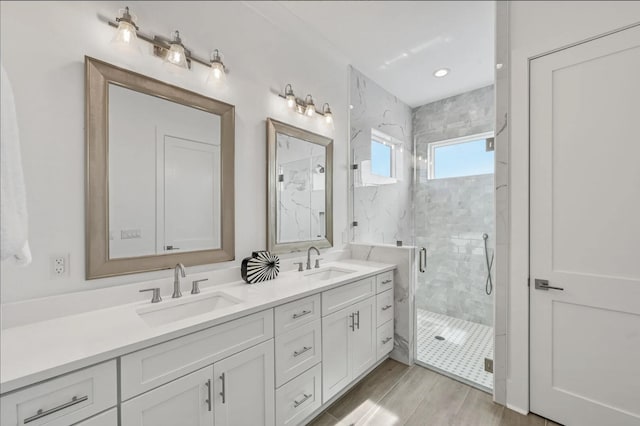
412,86,496,325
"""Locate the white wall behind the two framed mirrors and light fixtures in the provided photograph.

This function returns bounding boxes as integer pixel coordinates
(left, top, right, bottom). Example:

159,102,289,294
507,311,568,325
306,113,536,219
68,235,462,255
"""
0,1,347,303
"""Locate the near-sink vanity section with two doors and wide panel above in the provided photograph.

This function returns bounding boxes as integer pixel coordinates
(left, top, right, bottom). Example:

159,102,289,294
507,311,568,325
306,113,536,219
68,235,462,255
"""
120,309,275,426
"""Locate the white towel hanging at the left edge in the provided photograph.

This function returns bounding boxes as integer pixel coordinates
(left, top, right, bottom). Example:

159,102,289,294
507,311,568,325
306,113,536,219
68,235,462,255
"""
0,65,31,265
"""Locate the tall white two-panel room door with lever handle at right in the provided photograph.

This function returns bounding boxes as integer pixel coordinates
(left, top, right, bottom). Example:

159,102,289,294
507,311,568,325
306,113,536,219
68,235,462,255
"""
530,26,640,426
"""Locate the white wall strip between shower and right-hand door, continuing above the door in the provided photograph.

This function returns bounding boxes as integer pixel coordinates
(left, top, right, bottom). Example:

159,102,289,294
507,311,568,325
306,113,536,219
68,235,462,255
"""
498,1,640,412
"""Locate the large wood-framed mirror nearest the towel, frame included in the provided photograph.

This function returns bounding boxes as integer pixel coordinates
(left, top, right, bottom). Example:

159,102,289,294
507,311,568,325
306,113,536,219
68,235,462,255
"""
85,57,235,279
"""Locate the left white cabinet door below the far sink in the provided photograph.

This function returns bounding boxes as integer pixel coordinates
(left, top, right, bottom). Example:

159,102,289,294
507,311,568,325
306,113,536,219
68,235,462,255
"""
322,307,354,404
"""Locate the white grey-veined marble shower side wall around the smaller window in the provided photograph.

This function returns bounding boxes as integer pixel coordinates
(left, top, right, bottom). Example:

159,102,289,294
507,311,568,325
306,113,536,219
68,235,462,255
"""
350,68,413,244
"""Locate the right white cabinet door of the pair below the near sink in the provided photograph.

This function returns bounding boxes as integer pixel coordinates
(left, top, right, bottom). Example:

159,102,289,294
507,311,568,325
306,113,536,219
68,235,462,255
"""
213,339,275,426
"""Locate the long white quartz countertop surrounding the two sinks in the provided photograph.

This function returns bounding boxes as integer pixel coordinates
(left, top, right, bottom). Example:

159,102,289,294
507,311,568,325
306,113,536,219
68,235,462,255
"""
0,260,395,394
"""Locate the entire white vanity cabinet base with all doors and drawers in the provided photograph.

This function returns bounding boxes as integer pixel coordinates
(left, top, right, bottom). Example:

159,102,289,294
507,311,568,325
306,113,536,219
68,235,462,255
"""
0,265,394,426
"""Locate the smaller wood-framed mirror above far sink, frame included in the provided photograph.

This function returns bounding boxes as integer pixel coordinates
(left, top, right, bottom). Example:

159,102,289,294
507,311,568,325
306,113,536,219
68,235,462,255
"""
267,118,333,253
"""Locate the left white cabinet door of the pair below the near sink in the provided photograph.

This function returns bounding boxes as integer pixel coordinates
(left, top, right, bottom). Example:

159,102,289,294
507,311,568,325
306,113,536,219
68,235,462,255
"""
121,366,213,426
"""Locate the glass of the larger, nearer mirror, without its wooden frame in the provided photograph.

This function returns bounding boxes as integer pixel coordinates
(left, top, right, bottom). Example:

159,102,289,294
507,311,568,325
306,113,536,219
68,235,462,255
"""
108,84,221,259
